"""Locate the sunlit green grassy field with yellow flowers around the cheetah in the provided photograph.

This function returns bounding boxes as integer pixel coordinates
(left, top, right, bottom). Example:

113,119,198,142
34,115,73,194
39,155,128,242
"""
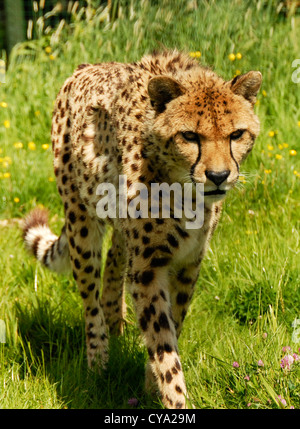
0,0,300,409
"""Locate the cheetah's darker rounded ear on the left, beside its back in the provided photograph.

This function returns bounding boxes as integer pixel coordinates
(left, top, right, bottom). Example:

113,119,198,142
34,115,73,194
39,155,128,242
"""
148,76,185,113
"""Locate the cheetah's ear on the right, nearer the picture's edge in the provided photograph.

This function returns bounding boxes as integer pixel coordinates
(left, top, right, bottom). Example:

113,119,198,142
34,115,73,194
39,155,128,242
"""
228,71,262,106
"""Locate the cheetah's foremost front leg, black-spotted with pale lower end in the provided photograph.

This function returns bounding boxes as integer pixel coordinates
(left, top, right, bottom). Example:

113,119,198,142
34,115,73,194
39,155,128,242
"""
131,259,186,409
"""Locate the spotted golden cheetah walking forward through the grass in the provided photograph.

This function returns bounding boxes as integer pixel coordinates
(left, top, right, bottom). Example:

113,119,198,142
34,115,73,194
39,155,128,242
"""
23,50,262,409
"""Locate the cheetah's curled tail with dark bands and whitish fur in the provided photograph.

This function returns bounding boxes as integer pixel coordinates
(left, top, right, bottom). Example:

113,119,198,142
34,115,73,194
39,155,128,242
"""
23,208,70,273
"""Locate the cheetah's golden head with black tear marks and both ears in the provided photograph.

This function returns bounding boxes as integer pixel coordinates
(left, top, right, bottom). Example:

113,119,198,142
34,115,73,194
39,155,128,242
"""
148,68,262,203
